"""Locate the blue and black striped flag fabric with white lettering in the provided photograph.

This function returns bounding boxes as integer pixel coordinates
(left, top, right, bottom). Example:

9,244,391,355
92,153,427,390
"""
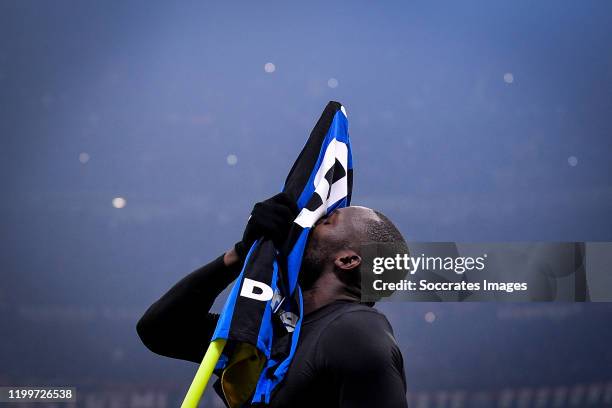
211,101,353,408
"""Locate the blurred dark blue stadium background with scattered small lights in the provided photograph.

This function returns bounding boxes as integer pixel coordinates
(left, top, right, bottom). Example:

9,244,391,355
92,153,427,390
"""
0,0,612,408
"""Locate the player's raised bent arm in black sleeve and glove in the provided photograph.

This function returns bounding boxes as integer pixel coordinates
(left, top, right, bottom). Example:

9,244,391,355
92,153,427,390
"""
136,193,297,363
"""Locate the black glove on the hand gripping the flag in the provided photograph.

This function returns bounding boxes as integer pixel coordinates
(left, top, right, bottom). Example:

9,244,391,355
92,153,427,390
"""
234,193,298,261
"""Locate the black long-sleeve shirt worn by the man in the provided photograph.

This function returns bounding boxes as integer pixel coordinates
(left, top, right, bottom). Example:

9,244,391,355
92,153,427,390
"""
137,253,407,408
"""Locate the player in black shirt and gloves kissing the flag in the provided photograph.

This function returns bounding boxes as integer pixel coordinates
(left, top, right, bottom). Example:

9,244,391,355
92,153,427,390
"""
137,193,408,408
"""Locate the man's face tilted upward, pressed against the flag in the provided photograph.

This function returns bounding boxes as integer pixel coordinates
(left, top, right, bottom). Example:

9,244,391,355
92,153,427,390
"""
299,206,378,290
